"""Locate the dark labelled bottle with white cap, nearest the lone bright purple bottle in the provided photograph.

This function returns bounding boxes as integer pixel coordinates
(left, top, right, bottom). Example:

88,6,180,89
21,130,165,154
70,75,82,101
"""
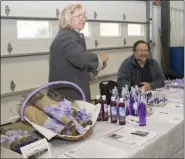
119,98,126,125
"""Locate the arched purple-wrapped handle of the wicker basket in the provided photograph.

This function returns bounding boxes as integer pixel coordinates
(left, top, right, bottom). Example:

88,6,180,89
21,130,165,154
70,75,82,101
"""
20,81,86,121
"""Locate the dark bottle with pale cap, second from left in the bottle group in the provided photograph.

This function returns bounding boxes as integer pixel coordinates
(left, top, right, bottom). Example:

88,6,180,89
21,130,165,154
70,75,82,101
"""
101,95,109,121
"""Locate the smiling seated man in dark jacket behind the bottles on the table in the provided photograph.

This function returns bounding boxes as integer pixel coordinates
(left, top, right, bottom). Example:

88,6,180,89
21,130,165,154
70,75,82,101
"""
117,40,165,94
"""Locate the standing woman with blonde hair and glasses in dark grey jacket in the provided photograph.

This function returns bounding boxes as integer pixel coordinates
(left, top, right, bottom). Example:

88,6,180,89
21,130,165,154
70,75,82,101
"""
49,4,109,102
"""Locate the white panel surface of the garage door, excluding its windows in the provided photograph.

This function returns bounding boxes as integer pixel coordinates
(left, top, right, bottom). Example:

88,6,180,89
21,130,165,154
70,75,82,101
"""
1,1,147,124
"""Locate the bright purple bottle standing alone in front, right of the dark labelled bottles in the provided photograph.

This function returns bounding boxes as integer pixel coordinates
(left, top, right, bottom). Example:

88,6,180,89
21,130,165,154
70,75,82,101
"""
138,101,146,126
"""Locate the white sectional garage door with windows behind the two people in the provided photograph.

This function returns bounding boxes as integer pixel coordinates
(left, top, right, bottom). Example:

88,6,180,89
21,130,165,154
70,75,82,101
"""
1,1,147,123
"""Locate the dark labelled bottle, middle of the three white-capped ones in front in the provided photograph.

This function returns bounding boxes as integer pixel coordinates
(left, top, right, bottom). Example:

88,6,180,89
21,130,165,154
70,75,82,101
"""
110,97,117,123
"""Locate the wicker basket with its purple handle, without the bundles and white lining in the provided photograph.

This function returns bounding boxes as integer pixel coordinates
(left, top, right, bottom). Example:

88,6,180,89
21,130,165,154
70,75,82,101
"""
20,81,95,141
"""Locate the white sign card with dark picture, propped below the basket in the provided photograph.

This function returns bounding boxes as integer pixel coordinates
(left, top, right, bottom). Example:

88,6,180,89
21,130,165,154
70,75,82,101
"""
21,138,52,158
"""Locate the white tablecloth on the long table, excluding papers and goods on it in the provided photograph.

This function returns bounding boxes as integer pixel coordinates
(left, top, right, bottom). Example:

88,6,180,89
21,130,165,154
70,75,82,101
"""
51,87,184,158
